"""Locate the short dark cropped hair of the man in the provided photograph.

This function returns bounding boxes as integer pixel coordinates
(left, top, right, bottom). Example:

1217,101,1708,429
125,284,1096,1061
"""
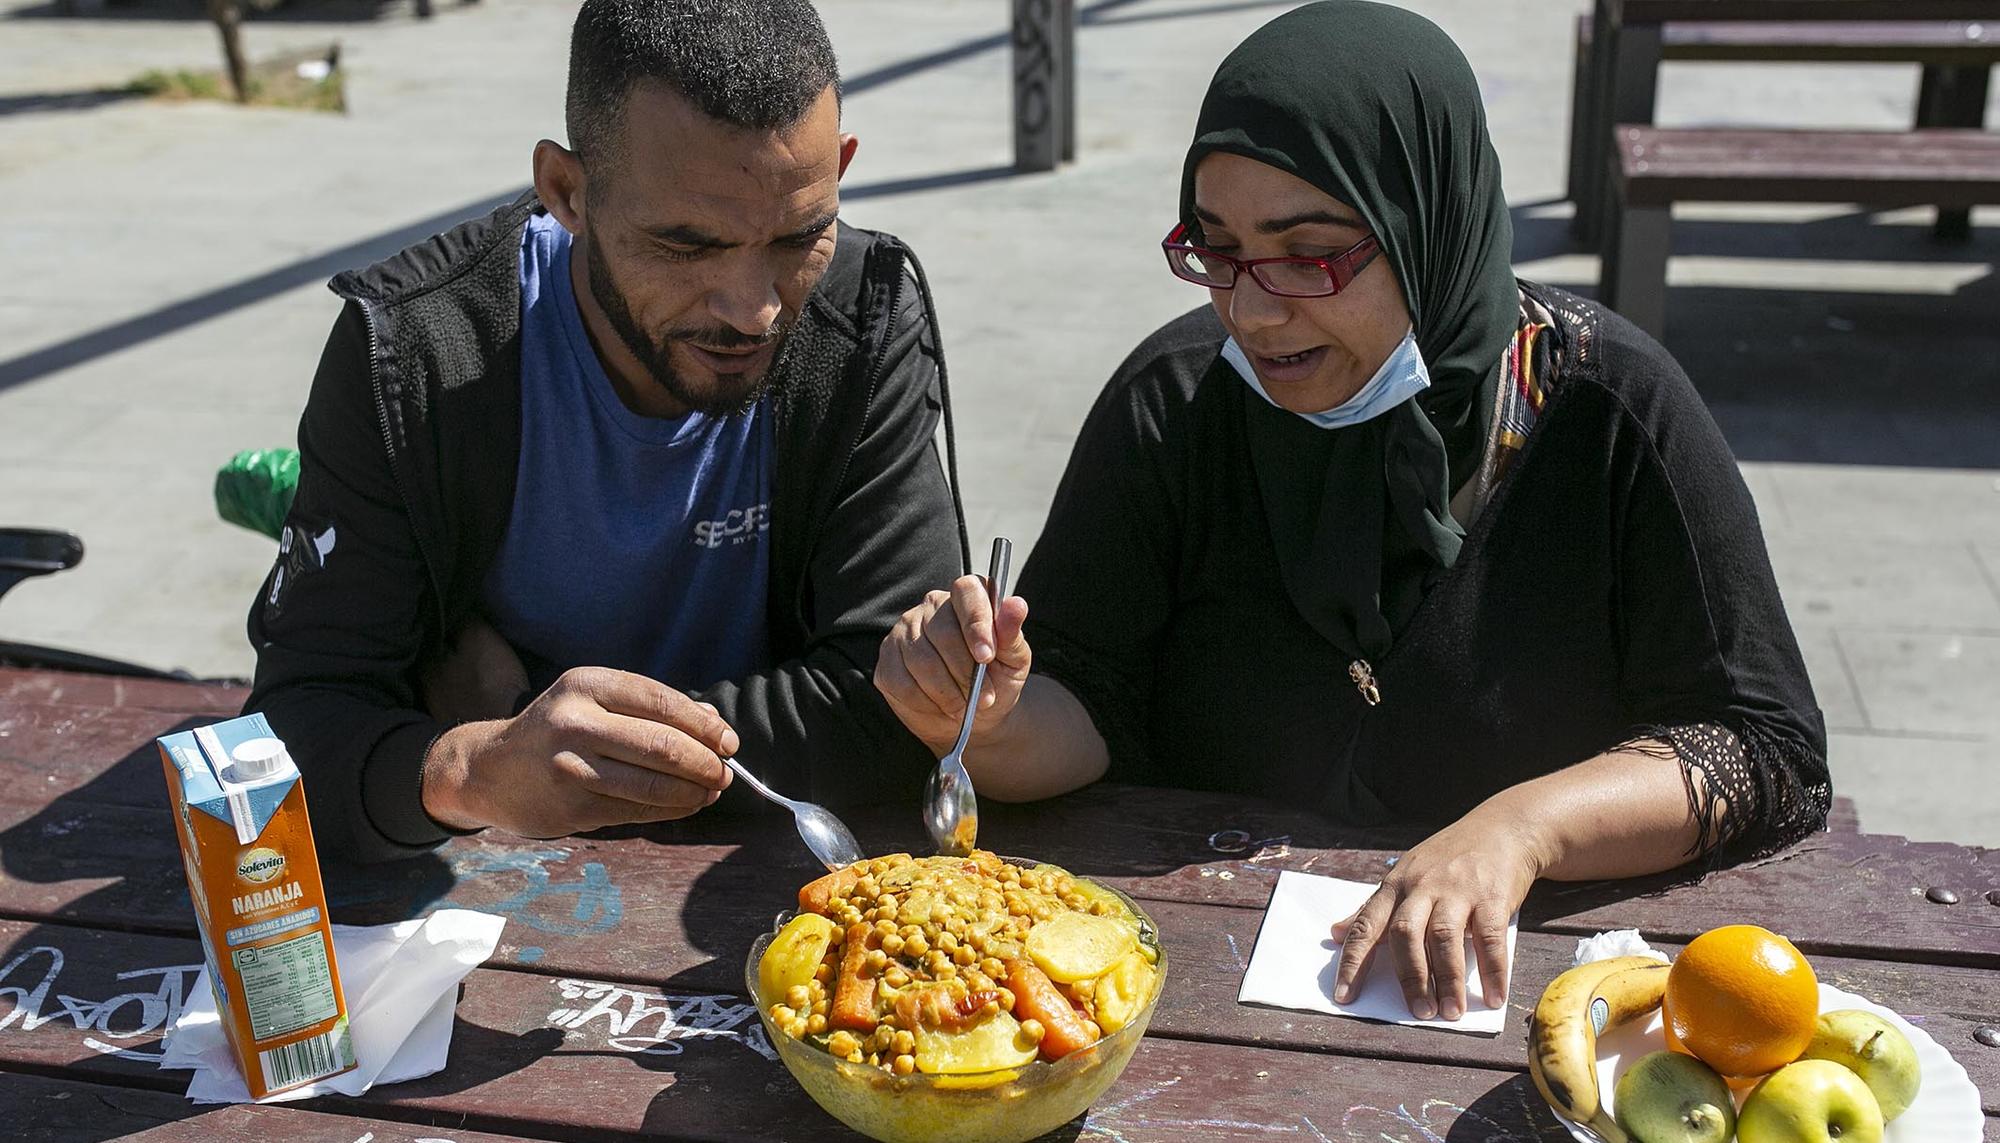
566,0,840,160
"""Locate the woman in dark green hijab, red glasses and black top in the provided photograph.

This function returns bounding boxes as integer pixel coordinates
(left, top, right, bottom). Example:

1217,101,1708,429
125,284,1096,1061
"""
876,0,1830,1019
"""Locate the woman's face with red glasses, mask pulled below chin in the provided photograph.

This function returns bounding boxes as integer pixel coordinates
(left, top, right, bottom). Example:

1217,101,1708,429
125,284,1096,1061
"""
1194,152,1410,414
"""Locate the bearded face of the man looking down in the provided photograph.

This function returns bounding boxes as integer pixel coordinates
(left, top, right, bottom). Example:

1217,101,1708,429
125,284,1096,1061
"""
582,84,852,414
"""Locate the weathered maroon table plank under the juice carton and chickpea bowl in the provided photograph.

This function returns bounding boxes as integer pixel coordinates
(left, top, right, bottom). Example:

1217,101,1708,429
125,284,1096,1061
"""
0,925,1608,1141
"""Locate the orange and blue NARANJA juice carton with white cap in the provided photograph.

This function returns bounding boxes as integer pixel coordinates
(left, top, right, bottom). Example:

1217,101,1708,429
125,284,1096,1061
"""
158,713,354,1099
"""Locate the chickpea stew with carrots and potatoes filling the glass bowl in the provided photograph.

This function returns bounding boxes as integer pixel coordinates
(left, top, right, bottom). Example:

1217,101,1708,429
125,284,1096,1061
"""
758,849,1160,1075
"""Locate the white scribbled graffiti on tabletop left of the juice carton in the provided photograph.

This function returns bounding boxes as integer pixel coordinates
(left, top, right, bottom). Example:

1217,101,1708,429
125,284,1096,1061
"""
0,945,202,1063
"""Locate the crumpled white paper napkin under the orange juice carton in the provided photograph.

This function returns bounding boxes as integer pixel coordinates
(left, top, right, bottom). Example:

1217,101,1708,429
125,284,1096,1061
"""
160,909,506,1103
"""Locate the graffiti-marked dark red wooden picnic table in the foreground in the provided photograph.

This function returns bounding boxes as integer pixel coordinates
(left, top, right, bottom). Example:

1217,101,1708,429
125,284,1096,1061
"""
0,669,2000,1143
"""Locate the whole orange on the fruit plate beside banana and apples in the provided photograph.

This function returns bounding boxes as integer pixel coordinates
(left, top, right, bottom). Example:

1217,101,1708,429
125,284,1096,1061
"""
1660,925,1820,1077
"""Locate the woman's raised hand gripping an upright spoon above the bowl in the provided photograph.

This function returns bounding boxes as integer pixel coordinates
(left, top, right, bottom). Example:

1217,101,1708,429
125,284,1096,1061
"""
874,575,1034,757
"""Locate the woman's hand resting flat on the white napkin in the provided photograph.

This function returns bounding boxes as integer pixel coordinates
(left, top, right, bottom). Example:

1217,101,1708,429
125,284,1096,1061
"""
1334,807,1544,1019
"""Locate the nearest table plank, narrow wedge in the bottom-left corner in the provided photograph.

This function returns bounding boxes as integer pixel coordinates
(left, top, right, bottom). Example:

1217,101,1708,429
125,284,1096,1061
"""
0,1073,548,1143
